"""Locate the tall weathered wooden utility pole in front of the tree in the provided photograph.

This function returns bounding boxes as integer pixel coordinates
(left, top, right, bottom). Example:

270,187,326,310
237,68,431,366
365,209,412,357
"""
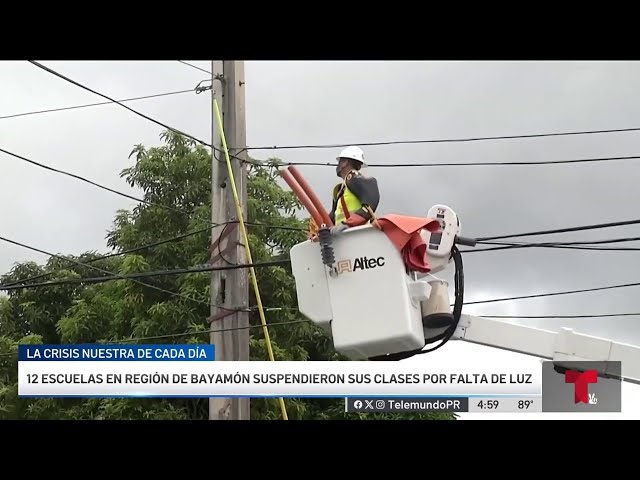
209,60,250,420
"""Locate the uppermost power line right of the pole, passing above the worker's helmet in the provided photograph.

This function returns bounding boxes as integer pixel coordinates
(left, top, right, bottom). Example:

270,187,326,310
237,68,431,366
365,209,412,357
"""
247,127,640,150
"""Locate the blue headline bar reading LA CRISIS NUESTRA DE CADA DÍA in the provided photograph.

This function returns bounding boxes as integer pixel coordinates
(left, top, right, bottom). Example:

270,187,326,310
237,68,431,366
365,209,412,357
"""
18,345,216,362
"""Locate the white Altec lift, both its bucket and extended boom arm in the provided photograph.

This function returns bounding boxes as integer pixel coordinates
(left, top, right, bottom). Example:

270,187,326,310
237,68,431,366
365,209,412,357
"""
290,205,640,383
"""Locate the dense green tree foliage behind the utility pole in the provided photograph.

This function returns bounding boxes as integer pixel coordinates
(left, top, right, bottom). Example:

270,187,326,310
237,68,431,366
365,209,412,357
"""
0,132,454,420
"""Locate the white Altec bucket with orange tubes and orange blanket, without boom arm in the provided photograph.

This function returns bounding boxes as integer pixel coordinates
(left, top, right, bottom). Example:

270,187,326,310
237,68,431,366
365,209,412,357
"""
282,167,476,360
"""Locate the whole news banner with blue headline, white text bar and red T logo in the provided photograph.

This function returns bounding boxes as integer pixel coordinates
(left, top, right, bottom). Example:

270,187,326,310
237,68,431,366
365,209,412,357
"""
18,344,622,413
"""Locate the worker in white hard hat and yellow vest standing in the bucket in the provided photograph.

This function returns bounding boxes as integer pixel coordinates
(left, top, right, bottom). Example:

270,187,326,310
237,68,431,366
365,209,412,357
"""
329,146,380,234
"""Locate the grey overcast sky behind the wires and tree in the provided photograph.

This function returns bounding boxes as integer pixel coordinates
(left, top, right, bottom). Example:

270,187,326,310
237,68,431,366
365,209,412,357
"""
0,61,640,418
